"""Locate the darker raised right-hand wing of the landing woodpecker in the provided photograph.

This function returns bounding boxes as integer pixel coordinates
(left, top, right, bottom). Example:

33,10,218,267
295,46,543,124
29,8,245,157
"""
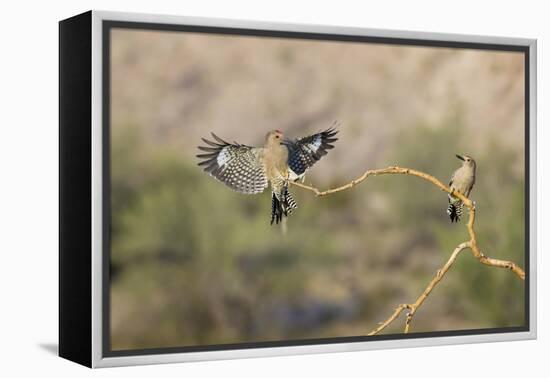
283,127,338,180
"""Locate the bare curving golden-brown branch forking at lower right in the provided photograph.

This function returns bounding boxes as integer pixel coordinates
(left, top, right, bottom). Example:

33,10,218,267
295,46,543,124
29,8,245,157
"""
292,166,525,336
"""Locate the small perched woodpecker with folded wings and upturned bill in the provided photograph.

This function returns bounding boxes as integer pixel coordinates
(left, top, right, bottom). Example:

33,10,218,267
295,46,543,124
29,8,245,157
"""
447,155,476,223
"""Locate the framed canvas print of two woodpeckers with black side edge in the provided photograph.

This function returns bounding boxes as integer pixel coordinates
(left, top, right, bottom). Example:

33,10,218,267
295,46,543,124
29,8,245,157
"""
59,11,536,367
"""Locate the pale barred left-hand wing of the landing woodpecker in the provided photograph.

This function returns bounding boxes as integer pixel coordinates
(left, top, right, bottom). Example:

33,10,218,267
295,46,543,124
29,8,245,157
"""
197,133,268,194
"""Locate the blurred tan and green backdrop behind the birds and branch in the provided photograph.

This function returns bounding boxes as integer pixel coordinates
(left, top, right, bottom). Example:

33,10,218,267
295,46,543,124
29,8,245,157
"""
111,29,525,350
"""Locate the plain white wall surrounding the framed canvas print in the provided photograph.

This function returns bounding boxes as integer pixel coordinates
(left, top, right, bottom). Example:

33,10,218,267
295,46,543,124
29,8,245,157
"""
0,0,550,377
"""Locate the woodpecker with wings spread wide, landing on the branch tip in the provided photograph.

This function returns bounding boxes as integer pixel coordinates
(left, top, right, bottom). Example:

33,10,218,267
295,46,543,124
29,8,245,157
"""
197,127,338,224
